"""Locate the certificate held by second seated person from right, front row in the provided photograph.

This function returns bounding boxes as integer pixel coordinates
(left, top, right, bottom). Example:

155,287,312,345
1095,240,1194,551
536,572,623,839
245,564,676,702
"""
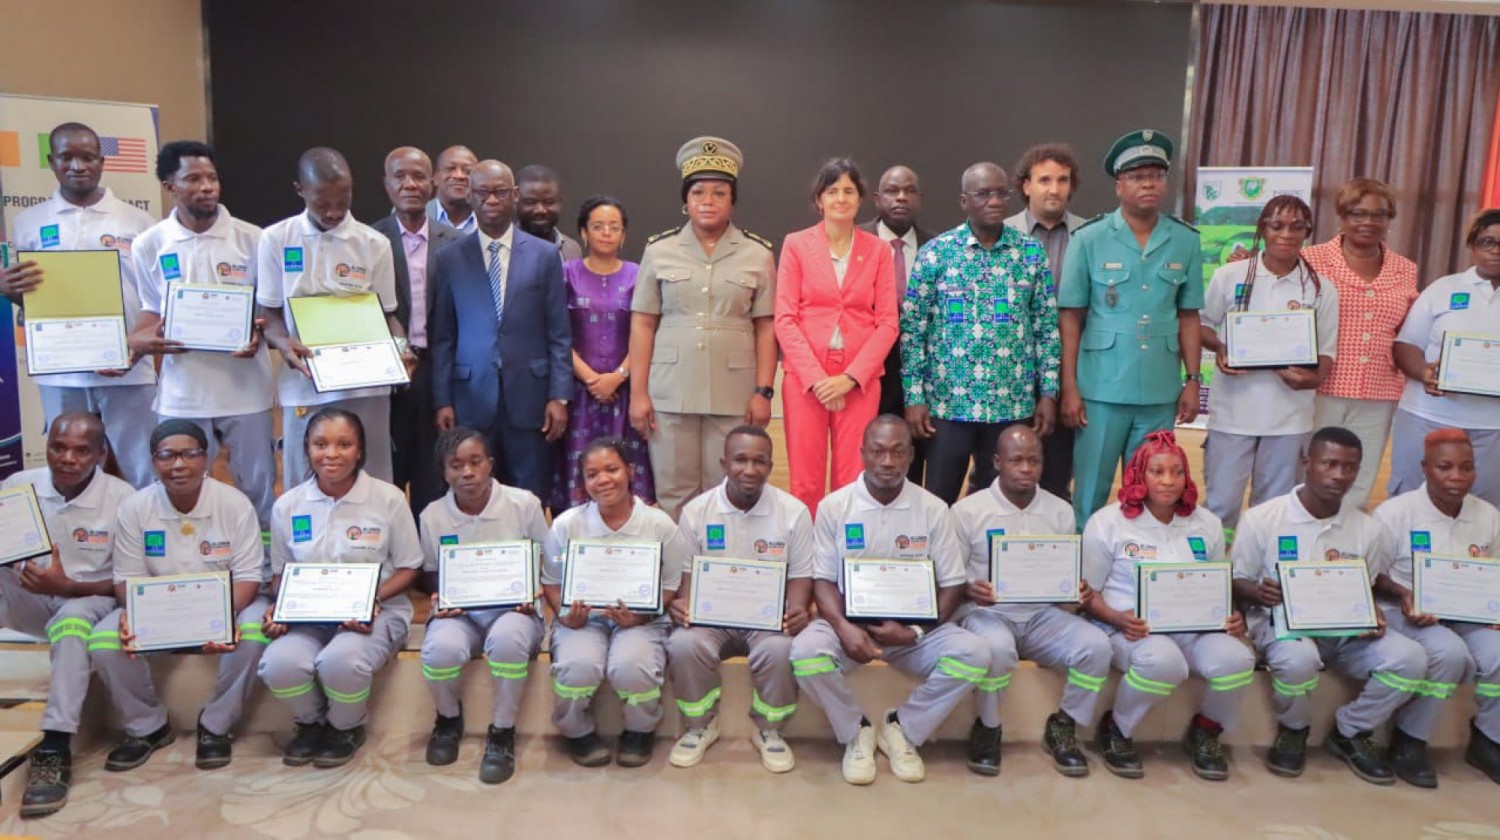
1277,560,1376,636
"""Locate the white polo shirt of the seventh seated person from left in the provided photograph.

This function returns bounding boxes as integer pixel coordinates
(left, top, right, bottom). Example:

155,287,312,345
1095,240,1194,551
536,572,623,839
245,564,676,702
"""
813,473,968,587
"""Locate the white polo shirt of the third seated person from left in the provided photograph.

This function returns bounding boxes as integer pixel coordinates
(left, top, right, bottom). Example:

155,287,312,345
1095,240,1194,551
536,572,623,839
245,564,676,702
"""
272,470,422,617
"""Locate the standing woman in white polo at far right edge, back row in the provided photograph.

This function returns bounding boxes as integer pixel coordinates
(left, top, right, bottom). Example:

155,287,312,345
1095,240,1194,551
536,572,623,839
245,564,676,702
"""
1389,207,1500,506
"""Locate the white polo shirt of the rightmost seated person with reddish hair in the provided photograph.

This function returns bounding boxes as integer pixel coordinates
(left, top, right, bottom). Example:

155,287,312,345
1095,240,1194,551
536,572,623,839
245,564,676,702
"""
1374,482,1500,590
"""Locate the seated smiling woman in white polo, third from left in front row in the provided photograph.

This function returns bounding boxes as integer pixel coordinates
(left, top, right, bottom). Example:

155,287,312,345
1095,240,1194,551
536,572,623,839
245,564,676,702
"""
260,407,422,767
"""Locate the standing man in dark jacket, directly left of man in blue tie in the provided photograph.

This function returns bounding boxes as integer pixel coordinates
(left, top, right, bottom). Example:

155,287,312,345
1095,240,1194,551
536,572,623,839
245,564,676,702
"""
371,146,462,516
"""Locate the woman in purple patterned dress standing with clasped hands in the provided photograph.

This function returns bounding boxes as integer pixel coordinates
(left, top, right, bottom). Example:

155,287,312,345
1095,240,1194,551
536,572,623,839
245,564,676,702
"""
549,195,656,516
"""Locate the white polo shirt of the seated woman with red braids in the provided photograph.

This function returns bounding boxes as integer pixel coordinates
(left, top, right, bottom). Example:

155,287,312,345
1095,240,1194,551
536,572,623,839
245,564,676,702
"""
1083,503,1224,611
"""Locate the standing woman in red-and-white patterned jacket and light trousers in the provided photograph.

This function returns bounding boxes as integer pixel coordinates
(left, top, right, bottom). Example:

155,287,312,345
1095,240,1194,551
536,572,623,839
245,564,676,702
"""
1302,179,1416,507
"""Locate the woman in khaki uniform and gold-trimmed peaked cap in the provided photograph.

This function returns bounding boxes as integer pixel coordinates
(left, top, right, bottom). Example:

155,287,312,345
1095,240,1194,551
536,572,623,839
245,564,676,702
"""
630,137,776,518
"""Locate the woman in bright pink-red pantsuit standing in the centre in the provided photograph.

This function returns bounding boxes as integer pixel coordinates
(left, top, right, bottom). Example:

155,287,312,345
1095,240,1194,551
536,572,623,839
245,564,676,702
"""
776,158,897,512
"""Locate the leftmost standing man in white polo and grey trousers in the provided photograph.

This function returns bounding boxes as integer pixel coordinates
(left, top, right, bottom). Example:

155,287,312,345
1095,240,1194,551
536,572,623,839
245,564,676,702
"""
0,123,156,488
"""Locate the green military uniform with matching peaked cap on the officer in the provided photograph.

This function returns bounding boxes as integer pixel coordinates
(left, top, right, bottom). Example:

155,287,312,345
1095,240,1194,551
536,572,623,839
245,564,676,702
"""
1058,131,1203,531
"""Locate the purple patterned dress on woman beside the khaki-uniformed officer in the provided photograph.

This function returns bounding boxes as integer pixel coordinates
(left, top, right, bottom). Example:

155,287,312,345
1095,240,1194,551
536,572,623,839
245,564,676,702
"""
549,260,656,516
